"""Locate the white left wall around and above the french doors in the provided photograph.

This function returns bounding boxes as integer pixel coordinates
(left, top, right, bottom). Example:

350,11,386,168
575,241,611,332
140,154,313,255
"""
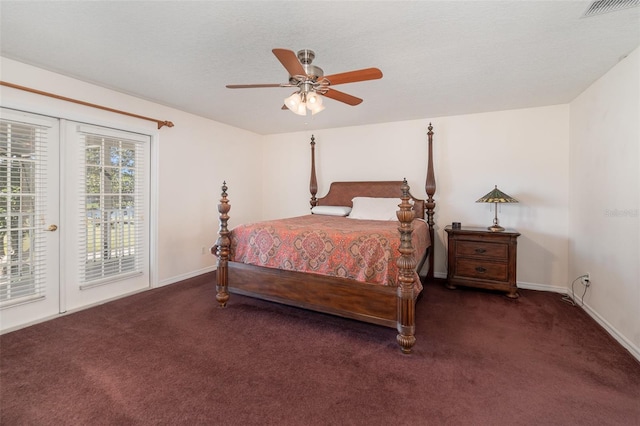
0,58,261,285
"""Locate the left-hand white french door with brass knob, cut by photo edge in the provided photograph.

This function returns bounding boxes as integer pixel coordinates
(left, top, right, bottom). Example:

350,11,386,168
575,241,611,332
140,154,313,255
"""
0,108,60,330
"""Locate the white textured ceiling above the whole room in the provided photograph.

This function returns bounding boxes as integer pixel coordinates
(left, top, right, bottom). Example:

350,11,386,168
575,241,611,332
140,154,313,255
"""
0,0,640,134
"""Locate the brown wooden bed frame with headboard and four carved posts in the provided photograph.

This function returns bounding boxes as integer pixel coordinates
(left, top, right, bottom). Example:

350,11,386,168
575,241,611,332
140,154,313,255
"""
211,124,436,353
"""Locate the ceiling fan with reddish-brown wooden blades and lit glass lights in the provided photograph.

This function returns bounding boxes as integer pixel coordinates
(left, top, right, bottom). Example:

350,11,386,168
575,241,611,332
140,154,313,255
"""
227,49,382,115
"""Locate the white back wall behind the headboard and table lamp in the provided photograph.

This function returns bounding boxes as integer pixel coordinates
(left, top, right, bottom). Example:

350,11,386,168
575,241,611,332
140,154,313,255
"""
262,105,569,290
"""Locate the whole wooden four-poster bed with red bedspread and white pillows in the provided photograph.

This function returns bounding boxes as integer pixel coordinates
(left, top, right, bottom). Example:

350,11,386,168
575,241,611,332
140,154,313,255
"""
211,125,436,353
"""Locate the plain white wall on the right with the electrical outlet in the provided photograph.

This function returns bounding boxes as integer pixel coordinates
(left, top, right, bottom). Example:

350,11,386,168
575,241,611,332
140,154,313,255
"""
569,49,640,359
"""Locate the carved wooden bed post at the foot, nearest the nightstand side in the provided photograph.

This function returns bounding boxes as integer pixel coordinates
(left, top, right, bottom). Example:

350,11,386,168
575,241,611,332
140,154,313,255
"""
396,179,417,354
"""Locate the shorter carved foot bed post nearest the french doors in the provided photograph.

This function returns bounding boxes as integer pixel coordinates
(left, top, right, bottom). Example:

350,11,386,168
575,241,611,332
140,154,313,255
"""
211,181,231,308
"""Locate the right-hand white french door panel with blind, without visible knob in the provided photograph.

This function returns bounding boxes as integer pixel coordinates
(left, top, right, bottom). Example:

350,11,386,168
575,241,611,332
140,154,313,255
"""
61,122,151,310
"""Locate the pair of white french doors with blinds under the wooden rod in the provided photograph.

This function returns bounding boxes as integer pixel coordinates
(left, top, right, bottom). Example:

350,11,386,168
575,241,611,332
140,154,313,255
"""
0,109,150,330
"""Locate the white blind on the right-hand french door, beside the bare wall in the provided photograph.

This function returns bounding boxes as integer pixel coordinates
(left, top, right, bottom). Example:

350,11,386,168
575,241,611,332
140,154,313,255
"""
78,127,146,288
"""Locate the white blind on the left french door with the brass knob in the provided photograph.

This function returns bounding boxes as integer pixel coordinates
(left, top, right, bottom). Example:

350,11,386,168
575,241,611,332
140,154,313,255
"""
0,119,48,307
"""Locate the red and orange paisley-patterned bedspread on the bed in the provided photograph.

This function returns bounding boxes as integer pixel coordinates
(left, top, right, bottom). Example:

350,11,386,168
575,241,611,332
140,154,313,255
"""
230,215,430,289
